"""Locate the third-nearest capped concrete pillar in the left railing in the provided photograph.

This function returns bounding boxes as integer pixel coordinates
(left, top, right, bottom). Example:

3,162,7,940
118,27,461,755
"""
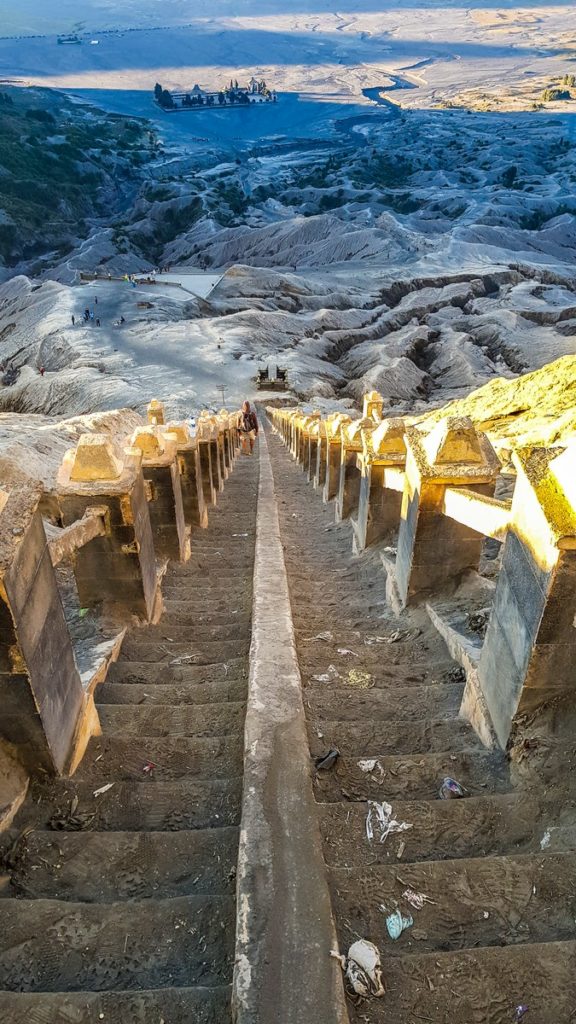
132,427,191,562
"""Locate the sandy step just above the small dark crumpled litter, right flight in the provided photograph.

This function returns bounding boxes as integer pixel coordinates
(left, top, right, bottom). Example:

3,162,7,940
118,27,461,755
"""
307,717,484,758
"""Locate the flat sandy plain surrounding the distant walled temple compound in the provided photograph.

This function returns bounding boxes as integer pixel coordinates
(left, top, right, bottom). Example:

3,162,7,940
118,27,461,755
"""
0,0,576,141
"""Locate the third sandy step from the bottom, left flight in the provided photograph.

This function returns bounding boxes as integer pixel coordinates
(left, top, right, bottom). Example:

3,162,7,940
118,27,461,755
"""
0,828,238,903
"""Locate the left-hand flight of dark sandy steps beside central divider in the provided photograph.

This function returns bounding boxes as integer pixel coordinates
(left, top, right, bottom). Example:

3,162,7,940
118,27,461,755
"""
0,459,257,1024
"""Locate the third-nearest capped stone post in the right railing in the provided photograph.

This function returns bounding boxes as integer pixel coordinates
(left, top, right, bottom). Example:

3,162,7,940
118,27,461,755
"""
353,418,406,551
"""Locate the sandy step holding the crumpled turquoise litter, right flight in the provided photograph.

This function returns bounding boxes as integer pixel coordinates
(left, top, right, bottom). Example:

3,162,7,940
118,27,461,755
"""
330,853,576,950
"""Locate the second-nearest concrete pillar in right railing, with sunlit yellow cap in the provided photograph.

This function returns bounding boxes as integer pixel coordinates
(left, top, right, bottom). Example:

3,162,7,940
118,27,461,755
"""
396,417,499,607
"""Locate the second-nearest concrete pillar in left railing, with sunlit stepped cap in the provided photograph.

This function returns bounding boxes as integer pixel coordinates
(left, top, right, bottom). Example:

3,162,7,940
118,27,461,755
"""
57,434,158,620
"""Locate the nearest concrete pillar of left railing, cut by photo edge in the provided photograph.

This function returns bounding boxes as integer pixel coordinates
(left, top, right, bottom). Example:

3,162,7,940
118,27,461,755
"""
0,487,90,774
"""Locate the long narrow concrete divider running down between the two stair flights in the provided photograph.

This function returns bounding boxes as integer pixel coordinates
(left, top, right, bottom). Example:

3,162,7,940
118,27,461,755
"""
233,421,348,1024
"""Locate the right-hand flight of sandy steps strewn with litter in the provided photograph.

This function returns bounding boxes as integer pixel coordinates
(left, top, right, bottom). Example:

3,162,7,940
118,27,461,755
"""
269,421,576,1024
